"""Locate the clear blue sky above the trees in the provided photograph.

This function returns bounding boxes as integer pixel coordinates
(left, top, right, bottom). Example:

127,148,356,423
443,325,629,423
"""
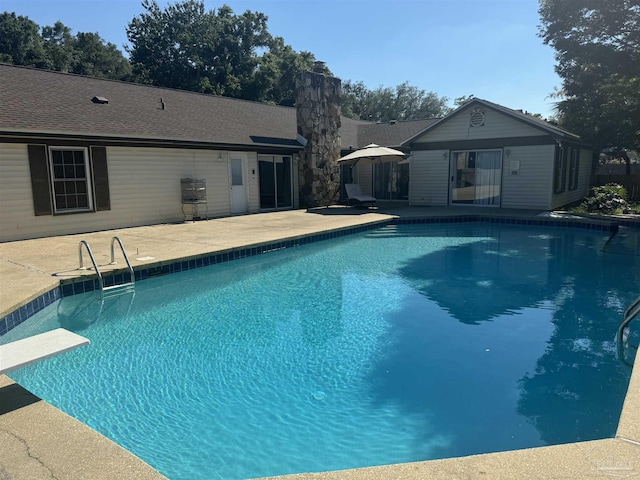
0,0,561,116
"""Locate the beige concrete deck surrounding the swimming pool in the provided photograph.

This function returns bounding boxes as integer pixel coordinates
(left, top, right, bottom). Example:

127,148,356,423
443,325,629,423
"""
0,206,640,480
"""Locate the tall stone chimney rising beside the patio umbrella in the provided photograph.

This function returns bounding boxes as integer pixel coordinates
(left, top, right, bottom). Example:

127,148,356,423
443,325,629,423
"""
296,62,341,208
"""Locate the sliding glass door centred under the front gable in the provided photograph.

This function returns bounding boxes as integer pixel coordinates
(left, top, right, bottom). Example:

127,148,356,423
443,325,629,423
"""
451,150,502,206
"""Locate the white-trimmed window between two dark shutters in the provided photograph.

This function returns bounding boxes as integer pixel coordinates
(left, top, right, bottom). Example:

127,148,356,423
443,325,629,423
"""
49,147,93,213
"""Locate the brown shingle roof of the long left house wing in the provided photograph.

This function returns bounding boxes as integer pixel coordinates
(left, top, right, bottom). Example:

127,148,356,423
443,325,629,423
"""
0,65,296,145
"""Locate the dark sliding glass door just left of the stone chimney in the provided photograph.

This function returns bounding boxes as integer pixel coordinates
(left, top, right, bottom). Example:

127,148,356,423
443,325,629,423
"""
258,155,293,210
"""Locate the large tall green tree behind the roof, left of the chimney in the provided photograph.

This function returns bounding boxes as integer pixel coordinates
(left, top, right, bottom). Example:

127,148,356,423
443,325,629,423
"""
127,0,315,106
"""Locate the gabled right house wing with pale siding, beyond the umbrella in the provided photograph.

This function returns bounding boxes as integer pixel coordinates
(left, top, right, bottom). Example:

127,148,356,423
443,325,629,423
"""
343,99,592,210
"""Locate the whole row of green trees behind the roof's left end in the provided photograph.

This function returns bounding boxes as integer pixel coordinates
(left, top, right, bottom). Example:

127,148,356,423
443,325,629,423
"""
0,12,131,80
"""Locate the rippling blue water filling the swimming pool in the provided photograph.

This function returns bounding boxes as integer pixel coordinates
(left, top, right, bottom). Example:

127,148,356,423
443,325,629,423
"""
2,223,640,479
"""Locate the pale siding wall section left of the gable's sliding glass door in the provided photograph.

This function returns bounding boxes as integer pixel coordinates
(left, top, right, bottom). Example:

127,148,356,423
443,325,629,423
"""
409,150,449,205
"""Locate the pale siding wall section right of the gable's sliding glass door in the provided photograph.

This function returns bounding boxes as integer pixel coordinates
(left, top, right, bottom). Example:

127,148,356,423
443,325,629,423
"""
502,145,554,210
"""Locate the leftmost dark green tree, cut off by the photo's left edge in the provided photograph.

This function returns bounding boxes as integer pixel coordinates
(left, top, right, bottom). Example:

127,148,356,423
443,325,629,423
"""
0,12,48,68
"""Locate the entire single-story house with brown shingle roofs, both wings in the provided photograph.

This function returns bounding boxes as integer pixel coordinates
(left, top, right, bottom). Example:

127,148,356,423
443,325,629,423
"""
0,65,591,241
